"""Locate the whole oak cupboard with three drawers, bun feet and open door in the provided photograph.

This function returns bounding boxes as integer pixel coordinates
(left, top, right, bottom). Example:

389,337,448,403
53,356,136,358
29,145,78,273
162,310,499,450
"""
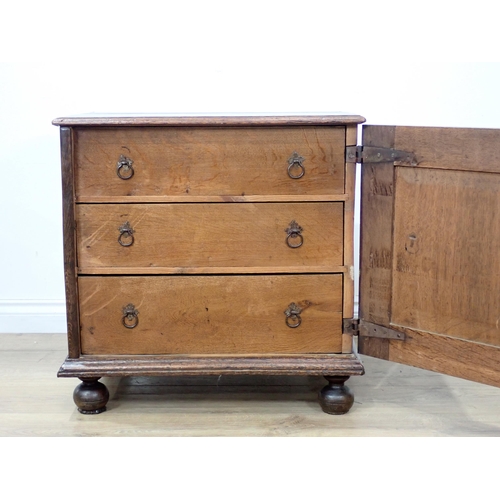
53,113,500,414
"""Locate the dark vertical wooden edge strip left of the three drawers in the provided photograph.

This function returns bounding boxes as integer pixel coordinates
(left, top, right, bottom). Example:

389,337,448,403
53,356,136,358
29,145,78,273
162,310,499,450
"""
60,127,80,358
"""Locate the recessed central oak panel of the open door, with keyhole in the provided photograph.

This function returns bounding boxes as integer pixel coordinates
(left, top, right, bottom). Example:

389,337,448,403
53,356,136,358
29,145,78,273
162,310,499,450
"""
391,168,500,346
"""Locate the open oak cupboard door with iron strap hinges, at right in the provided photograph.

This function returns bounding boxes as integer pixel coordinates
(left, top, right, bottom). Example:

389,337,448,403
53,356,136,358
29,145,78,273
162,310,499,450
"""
359,126,500,386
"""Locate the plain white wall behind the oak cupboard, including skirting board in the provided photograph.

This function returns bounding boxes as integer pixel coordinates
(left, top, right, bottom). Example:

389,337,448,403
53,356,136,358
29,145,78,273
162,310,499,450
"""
0,0,500,333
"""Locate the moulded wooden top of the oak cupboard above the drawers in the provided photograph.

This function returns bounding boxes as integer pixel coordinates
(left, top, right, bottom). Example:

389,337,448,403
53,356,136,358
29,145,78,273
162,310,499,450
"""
52,113,365,127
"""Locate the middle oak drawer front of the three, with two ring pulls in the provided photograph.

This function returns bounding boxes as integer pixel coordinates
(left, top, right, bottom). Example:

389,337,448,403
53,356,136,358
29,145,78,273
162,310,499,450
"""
76,202,343,274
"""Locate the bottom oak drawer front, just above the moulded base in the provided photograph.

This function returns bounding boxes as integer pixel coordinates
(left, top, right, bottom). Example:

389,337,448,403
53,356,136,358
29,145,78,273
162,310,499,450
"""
78,274,342,355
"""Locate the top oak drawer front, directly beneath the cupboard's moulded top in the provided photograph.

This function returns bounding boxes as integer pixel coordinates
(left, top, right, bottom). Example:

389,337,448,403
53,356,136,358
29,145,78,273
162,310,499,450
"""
74,126,345,203
